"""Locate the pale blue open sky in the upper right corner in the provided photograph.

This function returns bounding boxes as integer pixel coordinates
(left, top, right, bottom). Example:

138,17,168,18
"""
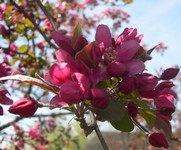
120,0,181,70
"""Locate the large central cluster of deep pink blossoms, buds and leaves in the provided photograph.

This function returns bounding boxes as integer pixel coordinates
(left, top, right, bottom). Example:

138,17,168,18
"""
44,25,179,147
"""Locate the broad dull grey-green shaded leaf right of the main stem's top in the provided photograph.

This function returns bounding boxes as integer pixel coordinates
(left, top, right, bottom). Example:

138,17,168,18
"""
93,100,126,121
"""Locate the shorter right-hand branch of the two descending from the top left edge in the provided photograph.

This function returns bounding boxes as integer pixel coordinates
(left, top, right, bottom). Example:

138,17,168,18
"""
36,0,57,31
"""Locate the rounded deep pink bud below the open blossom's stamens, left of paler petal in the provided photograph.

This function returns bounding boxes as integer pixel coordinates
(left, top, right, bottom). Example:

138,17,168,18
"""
107,62,126,77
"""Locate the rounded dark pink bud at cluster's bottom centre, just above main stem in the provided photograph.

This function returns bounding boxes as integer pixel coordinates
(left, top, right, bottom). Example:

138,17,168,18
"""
91,88,109,109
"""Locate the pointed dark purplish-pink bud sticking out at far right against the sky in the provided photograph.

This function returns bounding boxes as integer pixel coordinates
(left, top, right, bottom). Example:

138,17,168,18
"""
160,68,180,80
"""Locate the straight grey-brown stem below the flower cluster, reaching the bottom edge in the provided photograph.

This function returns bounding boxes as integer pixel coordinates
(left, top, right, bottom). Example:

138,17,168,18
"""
90,111,109,150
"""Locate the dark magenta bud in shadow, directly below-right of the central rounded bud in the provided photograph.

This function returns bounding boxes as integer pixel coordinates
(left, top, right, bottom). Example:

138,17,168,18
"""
118,77,136,95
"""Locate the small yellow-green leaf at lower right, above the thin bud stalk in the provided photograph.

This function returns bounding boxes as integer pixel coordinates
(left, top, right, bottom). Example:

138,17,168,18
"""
140,109,156,128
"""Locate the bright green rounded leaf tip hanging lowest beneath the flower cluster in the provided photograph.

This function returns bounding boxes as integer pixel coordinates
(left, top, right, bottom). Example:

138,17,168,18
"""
111,113,134,132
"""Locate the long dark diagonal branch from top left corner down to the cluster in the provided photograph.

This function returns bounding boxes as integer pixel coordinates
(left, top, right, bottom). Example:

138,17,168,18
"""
10,0,58,49
